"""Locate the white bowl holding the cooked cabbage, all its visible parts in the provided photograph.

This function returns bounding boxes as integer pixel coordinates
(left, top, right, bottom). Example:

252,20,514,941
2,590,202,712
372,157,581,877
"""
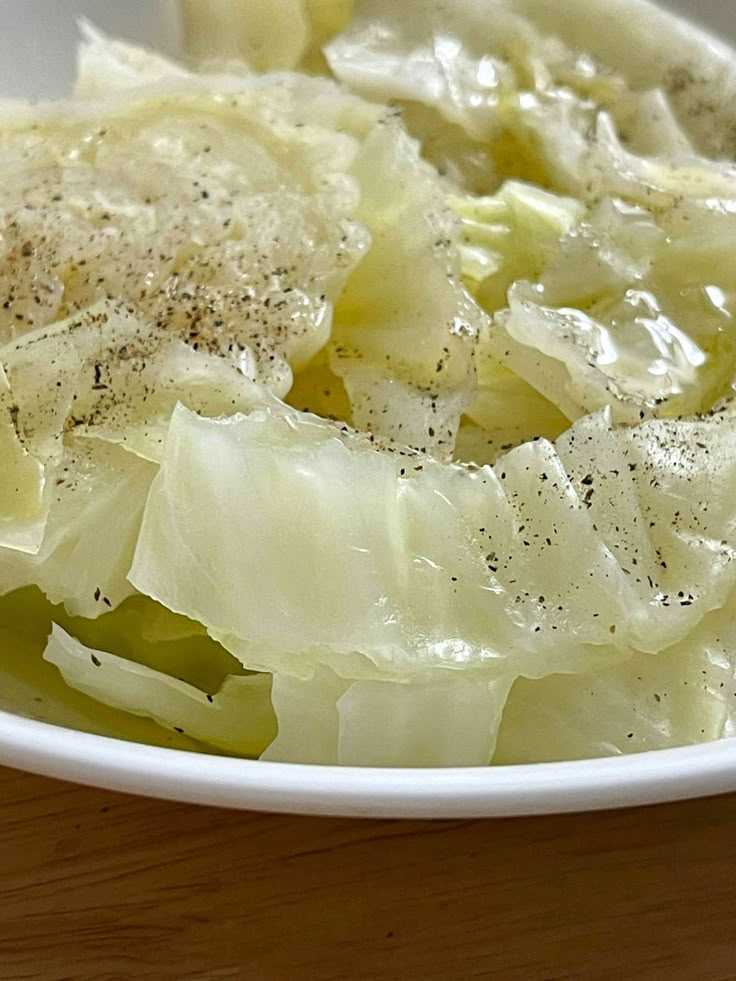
0,0,736,818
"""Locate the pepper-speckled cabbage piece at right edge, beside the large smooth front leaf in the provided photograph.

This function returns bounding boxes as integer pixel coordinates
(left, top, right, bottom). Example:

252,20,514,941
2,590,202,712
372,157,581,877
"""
556,415,736,652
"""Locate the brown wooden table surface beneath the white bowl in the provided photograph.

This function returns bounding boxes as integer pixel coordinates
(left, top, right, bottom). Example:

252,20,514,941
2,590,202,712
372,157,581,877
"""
0,770,736,981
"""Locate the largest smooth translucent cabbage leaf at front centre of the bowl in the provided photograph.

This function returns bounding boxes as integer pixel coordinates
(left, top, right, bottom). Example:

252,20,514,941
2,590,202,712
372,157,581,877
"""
130,409,668,680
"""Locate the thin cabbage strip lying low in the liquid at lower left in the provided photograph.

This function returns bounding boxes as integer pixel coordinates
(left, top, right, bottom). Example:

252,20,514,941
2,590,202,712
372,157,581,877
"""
43,625,276,756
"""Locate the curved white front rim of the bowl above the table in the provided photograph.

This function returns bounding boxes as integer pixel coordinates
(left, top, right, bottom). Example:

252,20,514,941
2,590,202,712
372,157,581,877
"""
0,711,736,819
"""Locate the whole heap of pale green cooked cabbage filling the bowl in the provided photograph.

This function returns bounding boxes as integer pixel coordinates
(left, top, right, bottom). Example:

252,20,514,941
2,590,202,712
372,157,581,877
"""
0,0,736,767
